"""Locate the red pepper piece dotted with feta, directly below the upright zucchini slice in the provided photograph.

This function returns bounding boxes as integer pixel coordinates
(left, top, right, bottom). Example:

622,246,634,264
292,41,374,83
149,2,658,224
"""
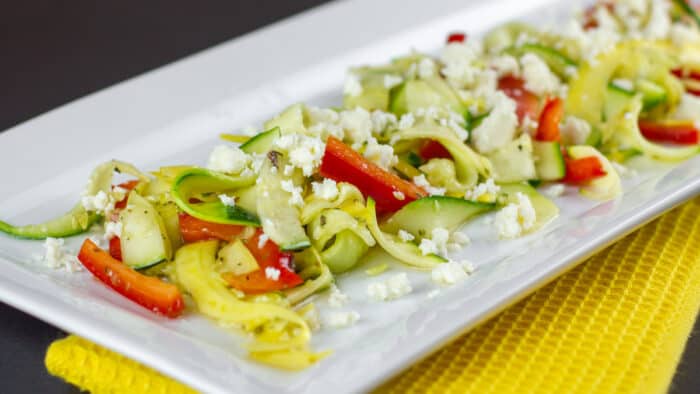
222,229,304,294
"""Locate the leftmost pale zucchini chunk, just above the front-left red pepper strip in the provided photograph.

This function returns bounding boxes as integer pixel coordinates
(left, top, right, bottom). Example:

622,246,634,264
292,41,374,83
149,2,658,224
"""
119,192,172,269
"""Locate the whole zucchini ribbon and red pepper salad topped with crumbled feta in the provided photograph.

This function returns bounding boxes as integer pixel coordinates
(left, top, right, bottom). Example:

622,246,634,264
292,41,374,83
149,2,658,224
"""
0,0,700,369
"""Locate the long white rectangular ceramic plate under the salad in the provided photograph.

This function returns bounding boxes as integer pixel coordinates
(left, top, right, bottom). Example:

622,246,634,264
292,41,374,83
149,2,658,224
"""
0,0,700,393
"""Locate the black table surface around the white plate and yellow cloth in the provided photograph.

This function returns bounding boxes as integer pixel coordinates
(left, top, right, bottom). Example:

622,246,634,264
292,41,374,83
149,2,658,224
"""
0,0,700,393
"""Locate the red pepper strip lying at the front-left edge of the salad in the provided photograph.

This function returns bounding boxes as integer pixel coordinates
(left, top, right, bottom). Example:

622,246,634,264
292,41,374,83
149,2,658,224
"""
78,239,185,318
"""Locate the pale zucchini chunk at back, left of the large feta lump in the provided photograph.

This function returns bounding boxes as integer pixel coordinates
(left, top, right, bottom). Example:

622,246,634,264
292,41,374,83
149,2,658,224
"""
389,77,463,116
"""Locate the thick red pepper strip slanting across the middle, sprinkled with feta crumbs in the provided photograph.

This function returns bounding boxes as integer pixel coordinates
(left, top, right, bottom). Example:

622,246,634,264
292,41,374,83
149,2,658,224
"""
319,137,427,213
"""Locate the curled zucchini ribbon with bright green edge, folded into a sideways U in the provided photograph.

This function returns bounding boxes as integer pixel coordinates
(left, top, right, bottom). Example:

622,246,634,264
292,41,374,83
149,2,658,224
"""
171,168,260,227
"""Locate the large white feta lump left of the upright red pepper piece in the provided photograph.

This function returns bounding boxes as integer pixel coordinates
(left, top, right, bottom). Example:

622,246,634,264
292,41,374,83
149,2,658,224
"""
472,91,518,153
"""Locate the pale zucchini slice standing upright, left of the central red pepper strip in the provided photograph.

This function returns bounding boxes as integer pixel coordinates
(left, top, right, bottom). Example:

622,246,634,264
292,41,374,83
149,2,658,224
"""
257,151,311,251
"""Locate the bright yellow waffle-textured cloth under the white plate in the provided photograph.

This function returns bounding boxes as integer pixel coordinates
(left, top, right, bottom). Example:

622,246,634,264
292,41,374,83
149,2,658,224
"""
46,198,700,394
